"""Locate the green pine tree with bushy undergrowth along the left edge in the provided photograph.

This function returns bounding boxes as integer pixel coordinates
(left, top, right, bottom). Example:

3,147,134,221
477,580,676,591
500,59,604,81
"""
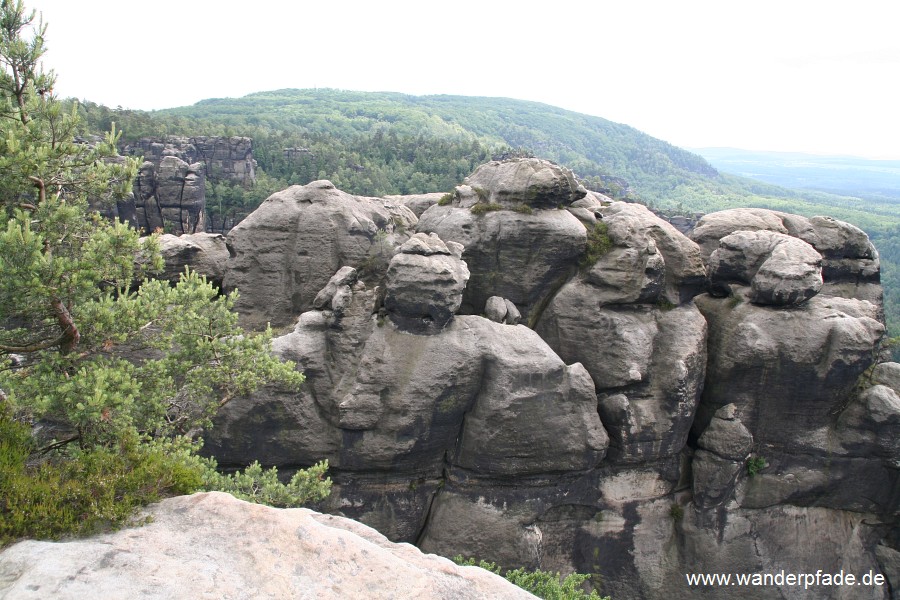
0,0,329,542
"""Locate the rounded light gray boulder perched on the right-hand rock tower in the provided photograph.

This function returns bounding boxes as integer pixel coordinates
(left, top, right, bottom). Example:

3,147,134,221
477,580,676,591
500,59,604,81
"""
709,231,822,306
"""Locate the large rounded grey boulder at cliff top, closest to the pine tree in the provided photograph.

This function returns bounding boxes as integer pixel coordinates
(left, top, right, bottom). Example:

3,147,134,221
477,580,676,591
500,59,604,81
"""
224,181,416,327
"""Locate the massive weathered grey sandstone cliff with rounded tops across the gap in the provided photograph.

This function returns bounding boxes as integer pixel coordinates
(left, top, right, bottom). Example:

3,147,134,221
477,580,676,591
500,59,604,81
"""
200,159,900,600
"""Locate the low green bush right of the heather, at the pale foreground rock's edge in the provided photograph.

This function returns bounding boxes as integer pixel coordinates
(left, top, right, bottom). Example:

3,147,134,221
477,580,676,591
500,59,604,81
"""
203,459,331,508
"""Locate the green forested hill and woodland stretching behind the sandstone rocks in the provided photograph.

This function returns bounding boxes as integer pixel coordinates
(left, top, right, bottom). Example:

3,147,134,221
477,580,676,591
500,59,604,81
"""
79,90,900,335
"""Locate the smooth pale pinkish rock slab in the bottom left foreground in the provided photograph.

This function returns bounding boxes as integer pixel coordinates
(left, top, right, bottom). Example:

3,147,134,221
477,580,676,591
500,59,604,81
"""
0,492,534,600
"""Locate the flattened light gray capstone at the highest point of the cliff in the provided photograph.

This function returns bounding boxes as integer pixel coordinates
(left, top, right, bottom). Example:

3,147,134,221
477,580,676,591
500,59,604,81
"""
463,158,587,208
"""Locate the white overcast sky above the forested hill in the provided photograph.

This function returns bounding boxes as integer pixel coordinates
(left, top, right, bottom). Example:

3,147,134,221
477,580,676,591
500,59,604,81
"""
26,0,900,159
